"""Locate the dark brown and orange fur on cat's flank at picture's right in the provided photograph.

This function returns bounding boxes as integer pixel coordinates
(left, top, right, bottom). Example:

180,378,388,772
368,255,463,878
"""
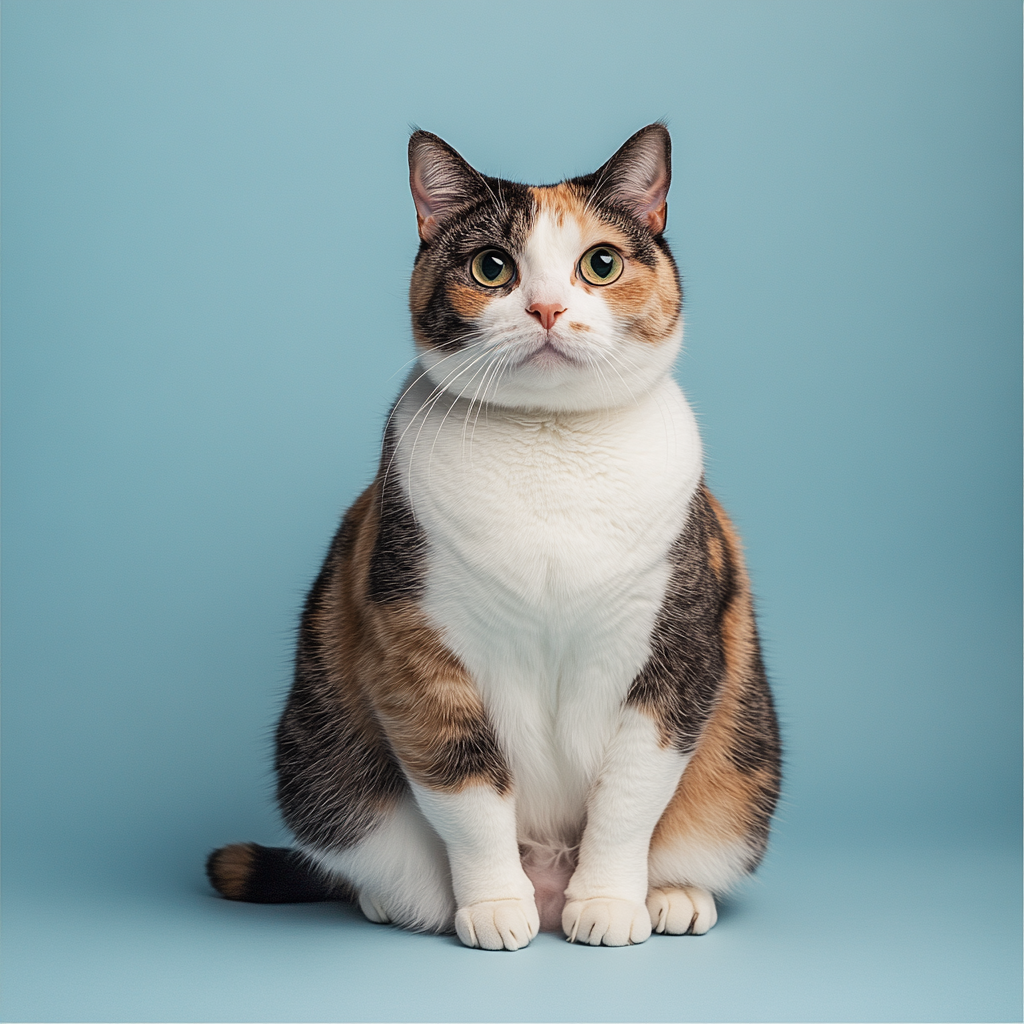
630,486,780,867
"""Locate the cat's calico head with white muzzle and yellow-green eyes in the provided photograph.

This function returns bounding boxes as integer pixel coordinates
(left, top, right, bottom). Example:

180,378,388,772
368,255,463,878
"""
409,124,682,411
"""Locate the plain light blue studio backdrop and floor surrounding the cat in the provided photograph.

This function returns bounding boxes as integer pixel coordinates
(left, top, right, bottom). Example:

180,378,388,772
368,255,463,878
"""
2,0,1021,1021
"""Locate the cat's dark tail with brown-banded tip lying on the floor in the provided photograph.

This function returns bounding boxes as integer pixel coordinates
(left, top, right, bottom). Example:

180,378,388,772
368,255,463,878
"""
206,843,355,903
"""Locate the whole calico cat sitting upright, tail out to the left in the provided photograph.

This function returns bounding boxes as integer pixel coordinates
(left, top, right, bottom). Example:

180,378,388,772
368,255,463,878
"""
208,124,779,949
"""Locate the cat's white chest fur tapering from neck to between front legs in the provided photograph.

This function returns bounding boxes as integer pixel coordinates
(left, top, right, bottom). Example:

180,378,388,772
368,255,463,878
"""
390,379,701,843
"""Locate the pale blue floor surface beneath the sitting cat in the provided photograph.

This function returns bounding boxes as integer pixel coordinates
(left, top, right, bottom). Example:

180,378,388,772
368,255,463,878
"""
3,835,1021,1022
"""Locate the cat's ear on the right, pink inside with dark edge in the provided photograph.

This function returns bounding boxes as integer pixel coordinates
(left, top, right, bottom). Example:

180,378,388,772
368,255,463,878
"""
595,124,672,234
